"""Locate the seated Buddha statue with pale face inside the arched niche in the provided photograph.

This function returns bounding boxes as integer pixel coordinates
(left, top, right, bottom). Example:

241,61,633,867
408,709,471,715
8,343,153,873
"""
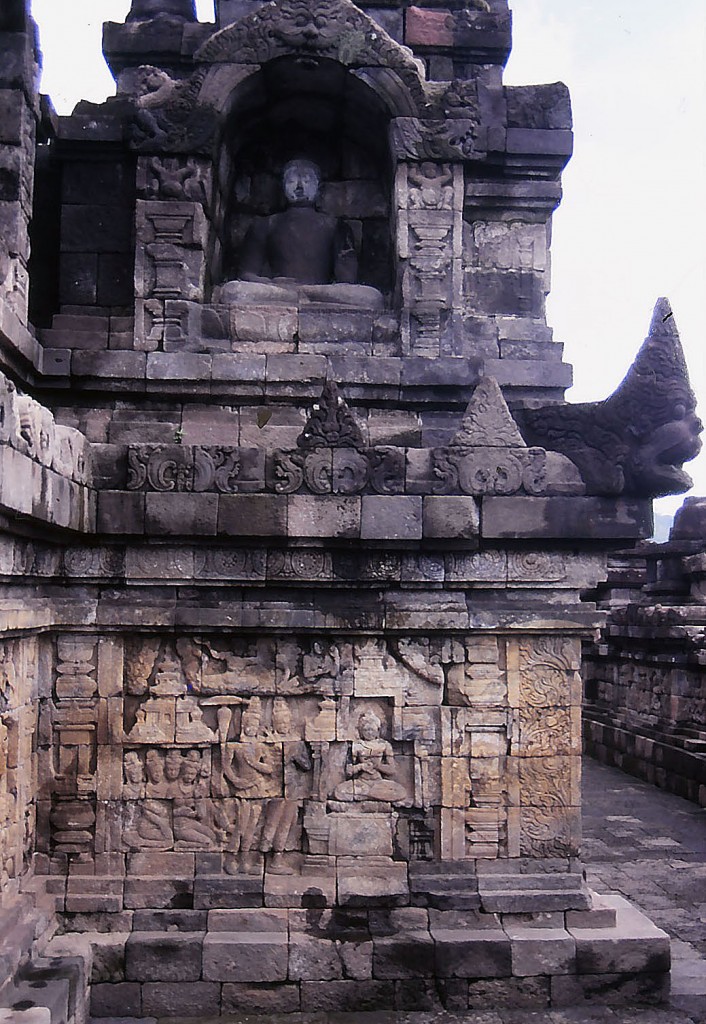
213,159,383,309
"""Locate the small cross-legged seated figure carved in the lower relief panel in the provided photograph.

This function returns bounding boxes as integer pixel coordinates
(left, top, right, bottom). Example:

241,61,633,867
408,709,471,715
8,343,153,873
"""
333,711,409,804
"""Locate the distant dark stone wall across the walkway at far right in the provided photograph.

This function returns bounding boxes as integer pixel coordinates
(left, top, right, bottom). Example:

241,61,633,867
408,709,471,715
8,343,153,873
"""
583,498,706,807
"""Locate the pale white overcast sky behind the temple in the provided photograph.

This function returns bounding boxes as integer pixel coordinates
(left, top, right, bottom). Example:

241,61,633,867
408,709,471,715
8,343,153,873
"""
27,0,706,513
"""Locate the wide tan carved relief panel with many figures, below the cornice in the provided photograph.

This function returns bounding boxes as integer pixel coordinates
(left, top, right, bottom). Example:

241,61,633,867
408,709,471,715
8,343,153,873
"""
42,633,580,874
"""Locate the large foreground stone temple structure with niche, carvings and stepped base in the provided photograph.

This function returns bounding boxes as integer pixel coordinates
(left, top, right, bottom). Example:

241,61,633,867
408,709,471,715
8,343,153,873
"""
0,0,701,1024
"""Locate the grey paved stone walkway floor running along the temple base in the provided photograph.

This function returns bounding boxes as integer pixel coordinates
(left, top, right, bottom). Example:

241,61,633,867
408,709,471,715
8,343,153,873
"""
93,758,706,1024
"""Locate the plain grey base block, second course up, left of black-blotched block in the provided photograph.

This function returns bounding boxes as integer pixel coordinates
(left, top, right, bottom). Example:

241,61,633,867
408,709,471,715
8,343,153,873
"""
203,932,287,982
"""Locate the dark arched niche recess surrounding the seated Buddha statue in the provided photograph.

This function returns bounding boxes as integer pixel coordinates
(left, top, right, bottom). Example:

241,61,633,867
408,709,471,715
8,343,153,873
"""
211,55,393,294
